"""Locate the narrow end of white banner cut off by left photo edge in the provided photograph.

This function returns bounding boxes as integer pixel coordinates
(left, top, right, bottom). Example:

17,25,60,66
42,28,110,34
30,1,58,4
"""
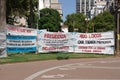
0,31,7,58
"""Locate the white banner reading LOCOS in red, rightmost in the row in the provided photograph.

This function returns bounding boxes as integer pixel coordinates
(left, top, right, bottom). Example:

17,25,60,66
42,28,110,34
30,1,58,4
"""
74,31,115,54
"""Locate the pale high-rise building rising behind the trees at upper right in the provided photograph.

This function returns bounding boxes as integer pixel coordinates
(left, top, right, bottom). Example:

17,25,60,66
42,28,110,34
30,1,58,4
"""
76,0,114,19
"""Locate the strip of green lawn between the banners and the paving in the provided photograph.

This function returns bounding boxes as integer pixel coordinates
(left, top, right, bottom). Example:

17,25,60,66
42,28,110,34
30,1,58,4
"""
0,53,113,64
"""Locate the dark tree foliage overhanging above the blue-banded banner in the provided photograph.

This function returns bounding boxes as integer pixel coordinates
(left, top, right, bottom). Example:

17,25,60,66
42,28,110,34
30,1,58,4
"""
6,0,38,27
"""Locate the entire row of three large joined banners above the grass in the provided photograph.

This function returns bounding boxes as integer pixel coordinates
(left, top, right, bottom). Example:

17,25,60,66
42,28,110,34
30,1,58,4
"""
5,25,115,54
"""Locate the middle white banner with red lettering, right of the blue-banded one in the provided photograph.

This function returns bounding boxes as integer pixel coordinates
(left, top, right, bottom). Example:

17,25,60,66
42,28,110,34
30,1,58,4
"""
38,31,70,52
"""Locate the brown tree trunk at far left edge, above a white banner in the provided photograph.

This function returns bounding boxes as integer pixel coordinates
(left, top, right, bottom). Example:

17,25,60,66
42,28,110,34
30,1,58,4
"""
0,0,6,30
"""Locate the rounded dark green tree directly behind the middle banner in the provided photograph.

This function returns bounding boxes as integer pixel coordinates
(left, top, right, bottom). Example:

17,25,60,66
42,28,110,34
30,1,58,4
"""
39,8,62,32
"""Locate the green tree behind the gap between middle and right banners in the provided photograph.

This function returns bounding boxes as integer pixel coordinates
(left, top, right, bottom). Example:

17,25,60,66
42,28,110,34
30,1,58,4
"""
64,13,86,32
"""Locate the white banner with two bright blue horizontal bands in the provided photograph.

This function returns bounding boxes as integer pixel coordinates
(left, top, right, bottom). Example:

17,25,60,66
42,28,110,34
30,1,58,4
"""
7,25,37,52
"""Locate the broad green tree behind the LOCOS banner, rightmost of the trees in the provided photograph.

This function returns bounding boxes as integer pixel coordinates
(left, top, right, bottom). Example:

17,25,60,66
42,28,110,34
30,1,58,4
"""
89,11,115,32
